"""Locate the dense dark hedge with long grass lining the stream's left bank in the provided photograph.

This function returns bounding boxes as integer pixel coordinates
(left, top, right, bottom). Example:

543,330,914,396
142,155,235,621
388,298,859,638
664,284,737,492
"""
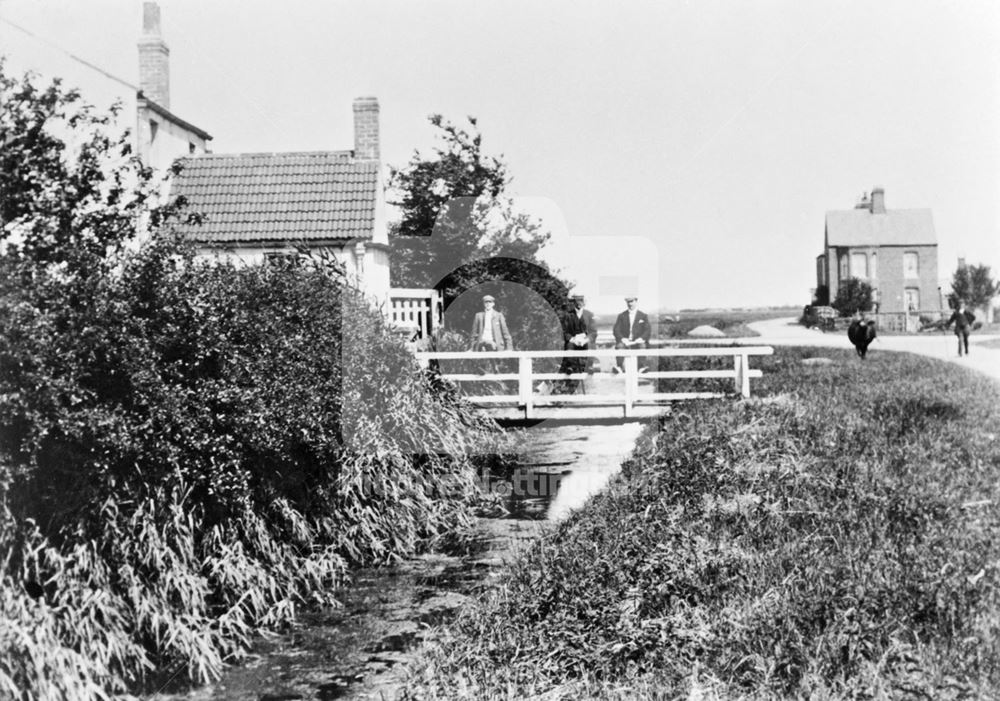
0,239,497,699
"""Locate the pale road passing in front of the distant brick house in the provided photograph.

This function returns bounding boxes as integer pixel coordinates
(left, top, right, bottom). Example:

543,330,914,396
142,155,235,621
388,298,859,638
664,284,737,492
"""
737,317,1000,381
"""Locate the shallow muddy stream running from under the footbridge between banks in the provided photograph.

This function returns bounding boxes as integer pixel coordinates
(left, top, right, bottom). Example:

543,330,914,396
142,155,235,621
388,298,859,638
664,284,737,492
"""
146,422,641,701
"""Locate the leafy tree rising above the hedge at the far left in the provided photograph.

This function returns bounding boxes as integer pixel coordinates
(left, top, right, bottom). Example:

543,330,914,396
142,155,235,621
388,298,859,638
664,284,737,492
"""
0,57,169,275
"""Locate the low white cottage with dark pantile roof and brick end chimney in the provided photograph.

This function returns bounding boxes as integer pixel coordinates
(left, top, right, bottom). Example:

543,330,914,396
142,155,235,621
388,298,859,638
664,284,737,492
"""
171,97,389,304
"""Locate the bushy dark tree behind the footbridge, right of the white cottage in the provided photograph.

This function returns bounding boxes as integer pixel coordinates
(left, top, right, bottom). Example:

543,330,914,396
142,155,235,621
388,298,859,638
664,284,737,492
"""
389,115,580,348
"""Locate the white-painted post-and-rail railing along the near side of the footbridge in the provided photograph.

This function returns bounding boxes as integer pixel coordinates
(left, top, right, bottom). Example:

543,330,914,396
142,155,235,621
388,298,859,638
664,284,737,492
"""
416,346,774,419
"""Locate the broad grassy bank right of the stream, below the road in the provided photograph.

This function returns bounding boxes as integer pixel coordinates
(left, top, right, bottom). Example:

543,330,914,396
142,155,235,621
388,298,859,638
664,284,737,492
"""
400,349,1000,699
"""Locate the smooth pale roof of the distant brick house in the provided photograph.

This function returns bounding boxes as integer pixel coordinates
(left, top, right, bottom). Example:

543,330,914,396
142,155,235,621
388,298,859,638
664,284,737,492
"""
826,209,937,246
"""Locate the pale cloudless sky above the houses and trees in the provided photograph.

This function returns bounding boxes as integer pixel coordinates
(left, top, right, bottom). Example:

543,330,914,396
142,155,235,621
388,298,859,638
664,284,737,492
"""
0,0,1000,311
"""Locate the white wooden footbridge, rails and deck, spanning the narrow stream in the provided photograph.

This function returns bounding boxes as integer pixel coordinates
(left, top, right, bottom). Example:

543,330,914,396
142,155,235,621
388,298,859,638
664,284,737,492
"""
416,346,774,420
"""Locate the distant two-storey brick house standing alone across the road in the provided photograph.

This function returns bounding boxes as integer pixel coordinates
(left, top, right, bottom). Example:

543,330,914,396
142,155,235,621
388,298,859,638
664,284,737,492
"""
816,187,941,314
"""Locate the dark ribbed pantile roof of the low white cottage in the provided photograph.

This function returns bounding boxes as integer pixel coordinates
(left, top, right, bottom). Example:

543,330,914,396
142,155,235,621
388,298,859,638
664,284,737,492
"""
171,151,378,244
